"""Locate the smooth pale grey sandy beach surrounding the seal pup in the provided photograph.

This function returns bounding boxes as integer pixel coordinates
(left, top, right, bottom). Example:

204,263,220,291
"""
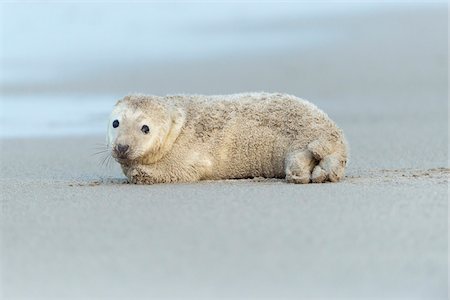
0,5,450,299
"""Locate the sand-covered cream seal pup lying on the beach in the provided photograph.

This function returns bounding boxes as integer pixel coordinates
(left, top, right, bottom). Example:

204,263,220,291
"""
107,93,347,184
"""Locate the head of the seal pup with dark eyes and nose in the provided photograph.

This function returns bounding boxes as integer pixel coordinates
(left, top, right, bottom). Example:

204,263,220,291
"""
107,95,184,164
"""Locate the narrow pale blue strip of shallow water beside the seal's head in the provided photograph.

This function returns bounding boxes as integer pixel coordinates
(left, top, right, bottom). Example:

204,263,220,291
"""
0,95,118,138
